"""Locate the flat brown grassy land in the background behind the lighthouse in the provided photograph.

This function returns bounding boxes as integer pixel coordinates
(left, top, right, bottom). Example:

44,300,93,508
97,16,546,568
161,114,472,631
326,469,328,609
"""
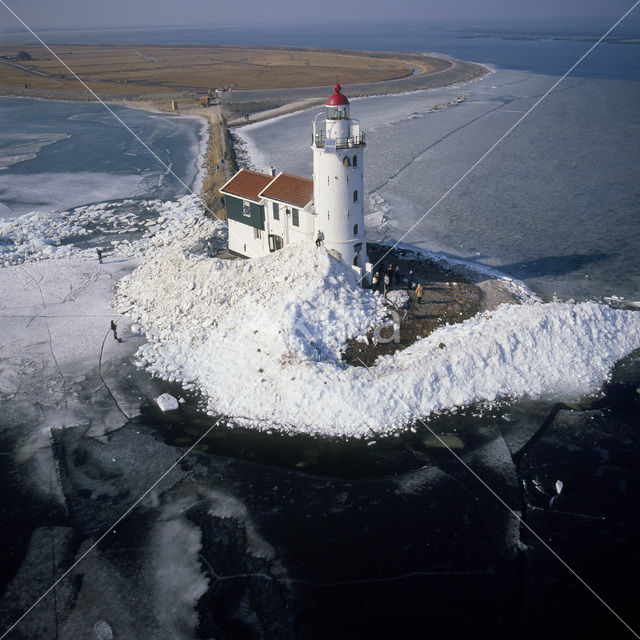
0,44,435,98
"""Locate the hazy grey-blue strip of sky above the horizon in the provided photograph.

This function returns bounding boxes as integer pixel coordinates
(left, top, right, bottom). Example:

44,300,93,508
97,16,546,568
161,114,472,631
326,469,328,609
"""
0,0,640,30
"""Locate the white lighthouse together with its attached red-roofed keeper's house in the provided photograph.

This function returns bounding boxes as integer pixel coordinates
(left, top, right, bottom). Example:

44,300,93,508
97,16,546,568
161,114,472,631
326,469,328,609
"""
220,84,371,276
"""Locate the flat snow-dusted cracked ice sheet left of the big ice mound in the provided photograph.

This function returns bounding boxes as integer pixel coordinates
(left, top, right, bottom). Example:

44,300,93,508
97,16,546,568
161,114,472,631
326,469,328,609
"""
0,259,145,485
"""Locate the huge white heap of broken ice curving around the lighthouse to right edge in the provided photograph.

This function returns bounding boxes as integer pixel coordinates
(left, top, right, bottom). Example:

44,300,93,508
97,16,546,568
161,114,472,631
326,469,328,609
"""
116,234,640,437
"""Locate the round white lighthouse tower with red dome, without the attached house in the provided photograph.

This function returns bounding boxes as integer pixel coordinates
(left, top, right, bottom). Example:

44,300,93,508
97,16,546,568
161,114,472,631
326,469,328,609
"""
311,84,370,275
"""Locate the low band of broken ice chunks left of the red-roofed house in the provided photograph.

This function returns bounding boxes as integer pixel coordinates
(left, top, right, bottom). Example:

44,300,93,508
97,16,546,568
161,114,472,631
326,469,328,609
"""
0,195,226,266
